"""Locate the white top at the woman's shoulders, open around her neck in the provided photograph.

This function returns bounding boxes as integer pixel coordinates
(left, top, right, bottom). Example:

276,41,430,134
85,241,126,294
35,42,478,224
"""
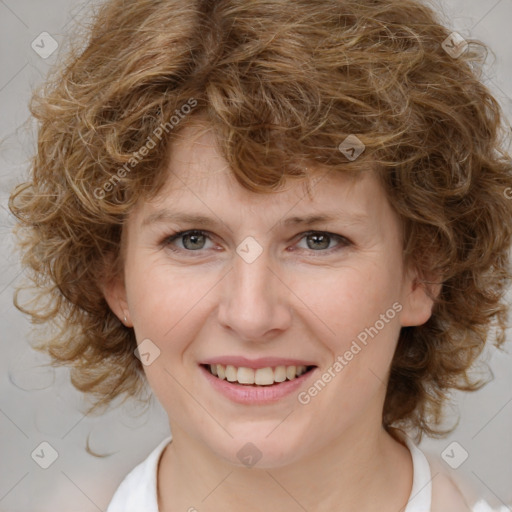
106,436,502,512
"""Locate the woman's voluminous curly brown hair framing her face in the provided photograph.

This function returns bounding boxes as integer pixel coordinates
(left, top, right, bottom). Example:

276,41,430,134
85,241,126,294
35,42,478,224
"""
9,0,512,437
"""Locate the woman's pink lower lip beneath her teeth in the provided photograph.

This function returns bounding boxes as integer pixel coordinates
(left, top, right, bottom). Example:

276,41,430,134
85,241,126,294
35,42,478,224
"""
199,366,316,405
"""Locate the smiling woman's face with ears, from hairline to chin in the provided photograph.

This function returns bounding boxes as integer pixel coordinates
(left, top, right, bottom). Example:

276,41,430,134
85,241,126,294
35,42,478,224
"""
106,122,432,467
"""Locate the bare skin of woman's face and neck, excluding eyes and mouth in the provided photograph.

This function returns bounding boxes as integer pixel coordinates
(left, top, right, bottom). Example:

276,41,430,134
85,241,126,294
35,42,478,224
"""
104,124,440,512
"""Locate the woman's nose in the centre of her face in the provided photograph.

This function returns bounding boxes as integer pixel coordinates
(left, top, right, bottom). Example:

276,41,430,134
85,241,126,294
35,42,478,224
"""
218,247,292,342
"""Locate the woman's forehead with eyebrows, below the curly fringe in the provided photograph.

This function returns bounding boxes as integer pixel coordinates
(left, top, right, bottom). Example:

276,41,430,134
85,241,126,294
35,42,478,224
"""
128,120,396,238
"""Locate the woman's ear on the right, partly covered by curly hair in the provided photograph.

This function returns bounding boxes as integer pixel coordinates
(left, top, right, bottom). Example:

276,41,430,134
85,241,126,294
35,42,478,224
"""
400,267,442,327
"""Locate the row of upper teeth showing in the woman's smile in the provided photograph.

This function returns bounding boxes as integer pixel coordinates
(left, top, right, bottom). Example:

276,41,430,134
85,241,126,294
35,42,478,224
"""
208,364,306,386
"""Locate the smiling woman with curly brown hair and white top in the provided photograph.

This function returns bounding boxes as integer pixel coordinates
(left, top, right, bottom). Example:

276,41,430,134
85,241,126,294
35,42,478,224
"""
11,0,512,512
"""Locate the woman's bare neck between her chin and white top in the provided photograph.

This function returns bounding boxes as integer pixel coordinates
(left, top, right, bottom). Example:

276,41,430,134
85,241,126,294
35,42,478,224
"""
158,420,412,512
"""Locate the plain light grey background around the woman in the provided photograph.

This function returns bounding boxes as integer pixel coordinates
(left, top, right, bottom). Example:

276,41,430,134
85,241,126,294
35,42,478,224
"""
0,0,512,512
